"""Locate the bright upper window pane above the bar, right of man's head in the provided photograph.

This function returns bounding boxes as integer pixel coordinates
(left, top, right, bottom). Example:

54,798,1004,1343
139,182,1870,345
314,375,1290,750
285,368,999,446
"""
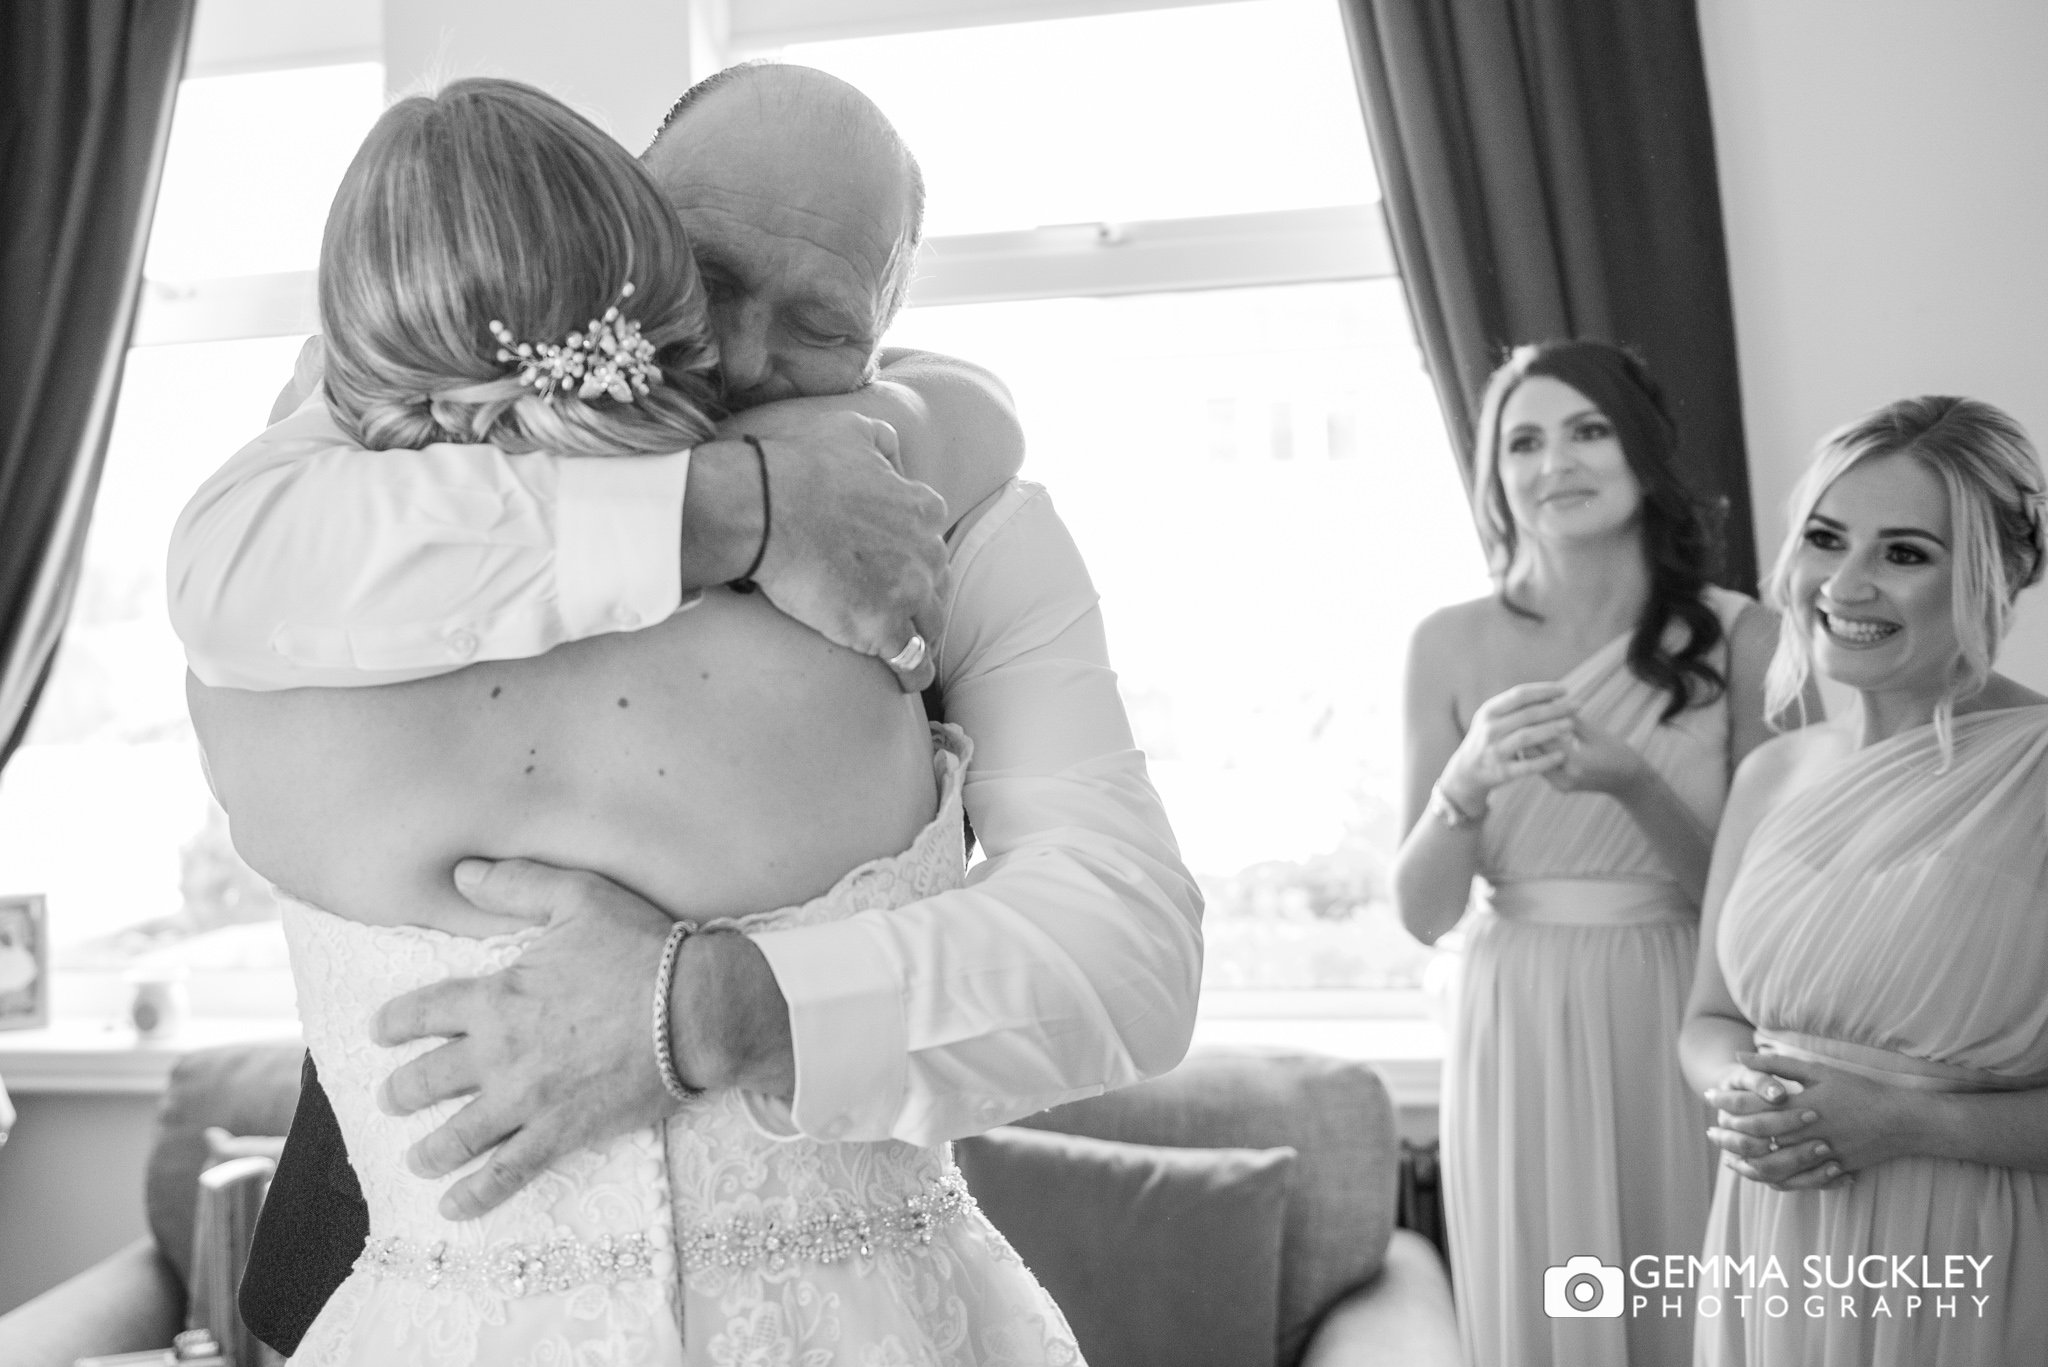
778,0,1378,236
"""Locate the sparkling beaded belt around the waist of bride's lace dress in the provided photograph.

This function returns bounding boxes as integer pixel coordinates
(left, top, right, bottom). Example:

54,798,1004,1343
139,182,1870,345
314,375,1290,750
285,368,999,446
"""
356,1172,975,1297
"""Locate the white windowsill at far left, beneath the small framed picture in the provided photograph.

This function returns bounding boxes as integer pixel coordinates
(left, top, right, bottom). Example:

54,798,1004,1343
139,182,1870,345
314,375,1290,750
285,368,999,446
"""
0,1019,299,1096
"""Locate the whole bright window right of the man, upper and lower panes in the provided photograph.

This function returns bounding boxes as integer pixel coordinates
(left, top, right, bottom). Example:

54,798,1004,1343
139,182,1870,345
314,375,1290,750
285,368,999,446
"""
761,0,1487,1010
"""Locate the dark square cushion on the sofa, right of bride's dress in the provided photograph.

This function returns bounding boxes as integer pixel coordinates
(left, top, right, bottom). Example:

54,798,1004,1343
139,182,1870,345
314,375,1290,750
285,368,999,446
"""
954,1127,1294,1367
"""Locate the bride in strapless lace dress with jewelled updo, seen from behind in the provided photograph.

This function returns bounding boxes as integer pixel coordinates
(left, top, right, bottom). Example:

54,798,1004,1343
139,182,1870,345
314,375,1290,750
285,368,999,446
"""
188,80,1079,1365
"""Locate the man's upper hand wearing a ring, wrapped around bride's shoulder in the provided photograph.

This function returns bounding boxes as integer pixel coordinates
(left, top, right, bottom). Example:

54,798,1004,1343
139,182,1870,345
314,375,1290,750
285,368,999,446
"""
684,400,946,693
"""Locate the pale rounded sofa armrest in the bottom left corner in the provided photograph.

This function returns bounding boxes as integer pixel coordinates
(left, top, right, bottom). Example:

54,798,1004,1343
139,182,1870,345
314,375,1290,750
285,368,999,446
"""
0,1236,184,1367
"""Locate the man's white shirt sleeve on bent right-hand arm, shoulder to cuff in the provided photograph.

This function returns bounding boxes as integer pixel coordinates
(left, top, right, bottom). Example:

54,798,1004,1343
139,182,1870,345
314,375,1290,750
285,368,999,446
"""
754,482,1202,1144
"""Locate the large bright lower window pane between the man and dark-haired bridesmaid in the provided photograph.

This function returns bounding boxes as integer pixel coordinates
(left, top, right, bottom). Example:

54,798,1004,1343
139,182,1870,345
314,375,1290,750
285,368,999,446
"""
889,279,1487,988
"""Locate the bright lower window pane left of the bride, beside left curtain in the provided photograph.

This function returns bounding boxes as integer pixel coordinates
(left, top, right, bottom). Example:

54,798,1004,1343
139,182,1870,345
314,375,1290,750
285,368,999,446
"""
0,338,305,987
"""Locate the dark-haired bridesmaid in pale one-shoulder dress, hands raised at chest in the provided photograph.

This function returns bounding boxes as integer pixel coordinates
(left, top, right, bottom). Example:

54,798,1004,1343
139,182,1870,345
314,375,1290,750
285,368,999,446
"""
1395,342,1776,1367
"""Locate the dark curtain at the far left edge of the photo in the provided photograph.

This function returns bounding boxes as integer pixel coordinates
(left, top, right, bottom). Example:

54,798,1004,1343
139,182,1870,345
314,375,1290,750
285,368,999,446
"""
0,0,193,764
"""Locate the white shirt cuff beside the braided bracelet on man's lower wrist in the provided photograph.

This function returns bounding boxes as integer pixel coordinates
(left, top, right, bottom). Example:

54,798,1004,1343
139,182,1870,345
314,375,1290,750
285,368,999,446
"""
754,916,909,1140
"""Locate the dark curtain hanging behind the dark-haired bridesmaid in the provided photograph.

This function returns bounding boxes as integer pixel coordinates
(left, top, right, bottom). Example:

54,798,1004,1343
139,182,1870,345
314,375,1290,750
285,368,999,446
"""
1339,0,1757,592
